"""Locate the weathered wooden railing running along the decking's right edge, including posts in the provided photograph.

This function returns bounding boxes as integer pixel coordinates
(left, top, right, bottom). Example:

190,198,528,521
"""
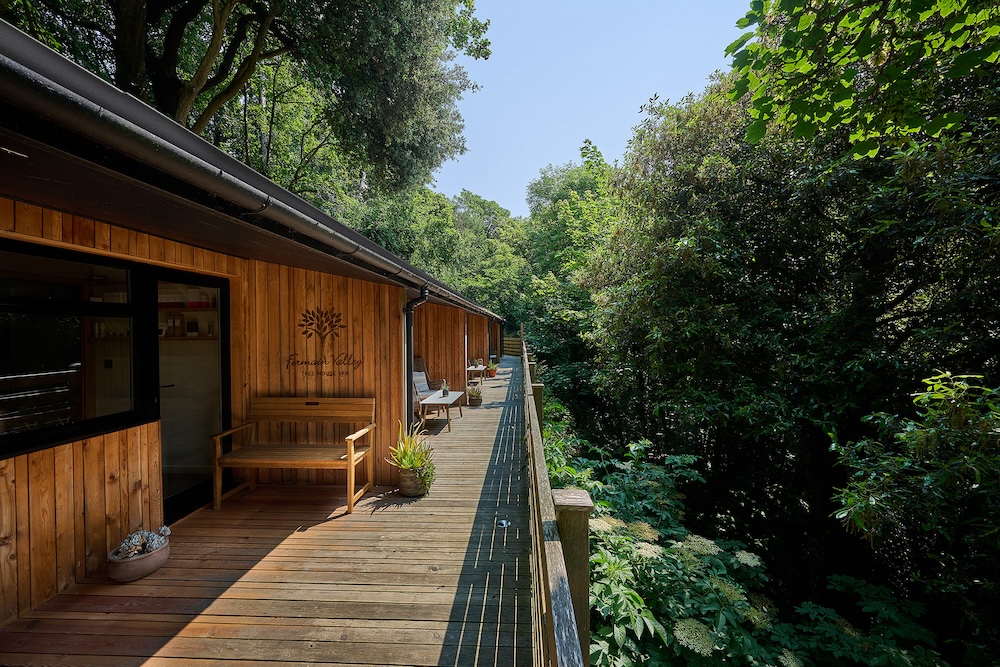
521,343,593,667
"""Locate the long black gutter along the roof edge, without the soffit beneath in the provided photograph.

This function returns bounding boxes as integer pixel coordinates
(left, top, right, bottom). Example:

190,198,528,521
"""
0,20,497,317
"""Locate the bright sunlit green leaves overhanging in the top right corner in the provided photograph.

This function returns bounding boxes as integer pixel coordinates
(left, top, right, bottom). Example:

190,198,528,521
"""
726,0,1000,152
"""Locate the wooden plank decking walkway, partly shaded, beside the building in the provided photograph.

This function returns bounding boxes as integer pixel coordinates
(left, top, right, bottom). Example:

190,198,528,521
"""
0,357,531,667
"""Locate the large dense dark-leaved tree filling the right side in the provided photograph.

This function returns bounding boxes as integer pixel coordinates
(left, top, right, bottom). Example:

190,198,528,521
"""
578,70,1000,634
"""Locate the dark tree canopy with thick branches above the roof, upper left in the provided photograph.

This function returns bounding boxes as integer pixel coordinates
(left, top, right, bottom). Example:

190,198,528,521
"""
0,0,489,184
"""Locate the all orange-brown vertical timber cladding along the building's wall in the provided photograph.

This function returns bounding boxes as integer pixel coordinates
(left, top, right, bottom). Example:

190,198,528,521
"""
0,197,414,624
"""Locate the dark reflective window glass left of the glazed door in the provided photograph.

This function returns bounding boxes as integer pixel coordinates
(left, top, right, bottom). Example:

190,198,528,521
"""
0,252,134,442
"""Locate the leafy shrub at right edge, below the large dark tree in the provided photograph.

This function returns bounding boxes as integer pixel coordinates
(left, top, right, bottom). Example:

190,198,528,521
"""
834,373,1000,655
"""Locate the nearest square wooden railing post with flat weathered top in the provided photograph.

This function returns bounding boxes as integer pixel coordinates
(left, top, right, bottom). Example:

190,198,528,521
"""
552,489,594,665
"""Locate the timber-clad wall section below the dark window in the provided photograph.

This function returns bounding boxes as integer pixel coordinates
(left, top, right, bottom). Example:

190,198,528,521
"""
0,422,163,625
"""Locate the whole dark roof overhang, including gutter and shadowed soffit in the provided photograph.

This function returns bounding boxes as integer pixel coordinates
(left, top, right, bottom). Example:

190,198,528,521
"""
0,21,502,319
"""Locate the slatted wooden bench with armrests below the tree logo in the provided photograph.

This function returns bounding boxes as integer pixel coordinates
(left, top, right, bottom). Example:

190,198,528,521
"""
212,396,375,513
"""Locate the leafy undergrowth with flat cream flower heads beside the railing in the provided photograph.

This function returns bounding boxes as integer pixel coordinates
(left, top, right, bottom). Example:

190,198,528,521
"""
544,404,945,666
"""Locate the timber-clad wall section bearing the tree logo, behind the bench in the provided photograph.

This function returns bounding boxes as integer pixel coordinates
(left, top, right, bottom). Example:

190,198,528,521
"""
246,262,404,484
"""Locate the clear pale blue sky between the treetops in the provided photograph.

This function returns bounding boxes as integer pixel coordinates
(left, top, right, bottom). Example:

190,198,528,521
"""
434,0,750,215
